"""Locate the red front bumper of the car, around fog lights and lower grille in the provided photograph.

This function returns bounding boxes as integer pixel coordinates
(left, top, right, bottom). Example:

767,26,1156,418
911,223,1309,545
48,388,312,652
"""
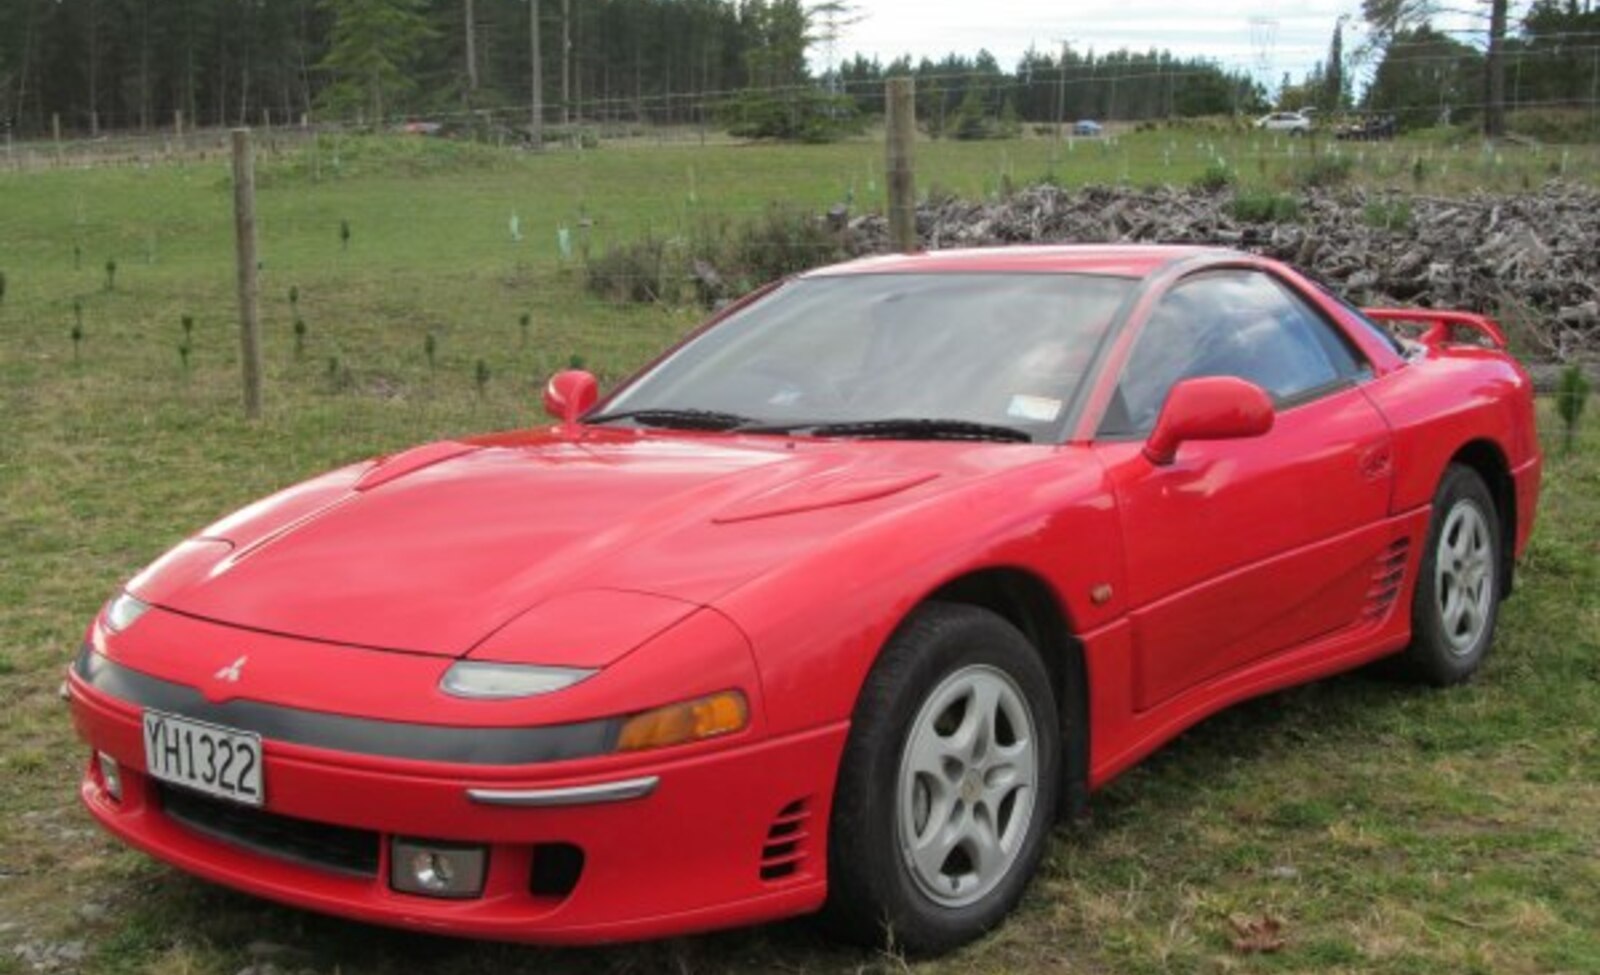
67,662,848,943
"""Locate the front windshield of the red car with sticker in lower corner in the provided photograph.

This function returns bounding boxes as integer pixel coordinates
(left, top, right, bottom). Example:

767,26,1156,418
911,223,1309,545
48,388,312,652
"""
589,274,1136,440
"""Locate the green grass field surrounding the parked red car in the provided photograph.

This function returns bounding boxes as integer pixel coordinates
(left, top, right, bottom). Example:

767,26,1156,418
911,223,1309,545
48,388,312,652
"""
0,133,1600,975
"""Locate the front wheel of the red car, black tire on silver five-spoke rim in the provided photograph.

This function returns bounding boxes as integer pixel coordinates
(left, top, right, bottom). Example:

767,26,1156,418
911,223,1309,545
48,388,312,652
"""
826,604,1061,954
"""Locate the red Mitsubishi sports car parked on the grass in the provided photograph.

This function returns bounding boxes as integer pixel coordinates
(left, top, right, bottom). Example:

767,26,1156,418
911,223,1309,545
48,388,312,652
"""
67,247,1539,951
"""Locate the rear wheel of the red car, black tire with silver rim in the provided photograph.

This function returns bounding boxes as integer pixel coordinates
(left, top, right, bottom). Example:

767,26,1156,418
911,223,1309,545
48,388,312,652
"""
1398,464,1502,687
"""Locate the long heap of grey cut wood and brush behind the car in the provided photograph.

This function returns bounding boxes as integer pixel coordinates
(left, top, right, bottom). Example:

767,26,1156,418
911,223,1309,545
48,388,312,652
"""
846,181,1600,362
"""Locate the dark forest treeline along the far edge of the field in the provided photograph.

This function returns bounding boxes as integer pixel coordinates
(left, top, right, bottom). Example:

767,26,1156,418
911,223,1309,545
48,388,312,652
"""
0,0,1600,138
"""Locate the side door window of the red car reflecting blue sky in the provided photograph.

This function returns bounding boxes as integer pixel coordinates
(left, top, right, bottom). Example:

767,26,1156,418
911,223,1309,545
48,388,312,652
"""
1101,271,1362,435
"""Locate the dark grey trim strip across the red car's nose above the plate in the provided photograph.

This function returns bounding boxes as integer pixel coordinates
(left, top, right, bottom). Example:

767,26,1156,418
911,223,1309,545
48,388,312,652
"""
72,645,619,765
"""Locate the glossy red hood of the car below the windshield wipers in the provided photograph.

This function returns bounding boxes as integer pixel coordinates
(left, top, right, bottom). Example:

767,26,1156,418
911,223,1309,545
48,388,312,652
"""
140,429,1051,656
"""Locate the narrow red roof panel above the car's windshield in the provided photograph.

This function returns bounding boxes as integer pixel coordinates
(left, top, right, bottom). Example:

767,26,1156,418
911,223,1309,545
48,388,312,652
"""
803,243,1242,279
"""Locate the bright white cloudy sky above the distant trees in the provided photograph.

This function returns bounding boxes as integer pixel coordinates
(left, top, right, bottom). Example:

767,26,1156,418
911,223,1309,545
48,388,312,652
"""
813,0,1484,85
